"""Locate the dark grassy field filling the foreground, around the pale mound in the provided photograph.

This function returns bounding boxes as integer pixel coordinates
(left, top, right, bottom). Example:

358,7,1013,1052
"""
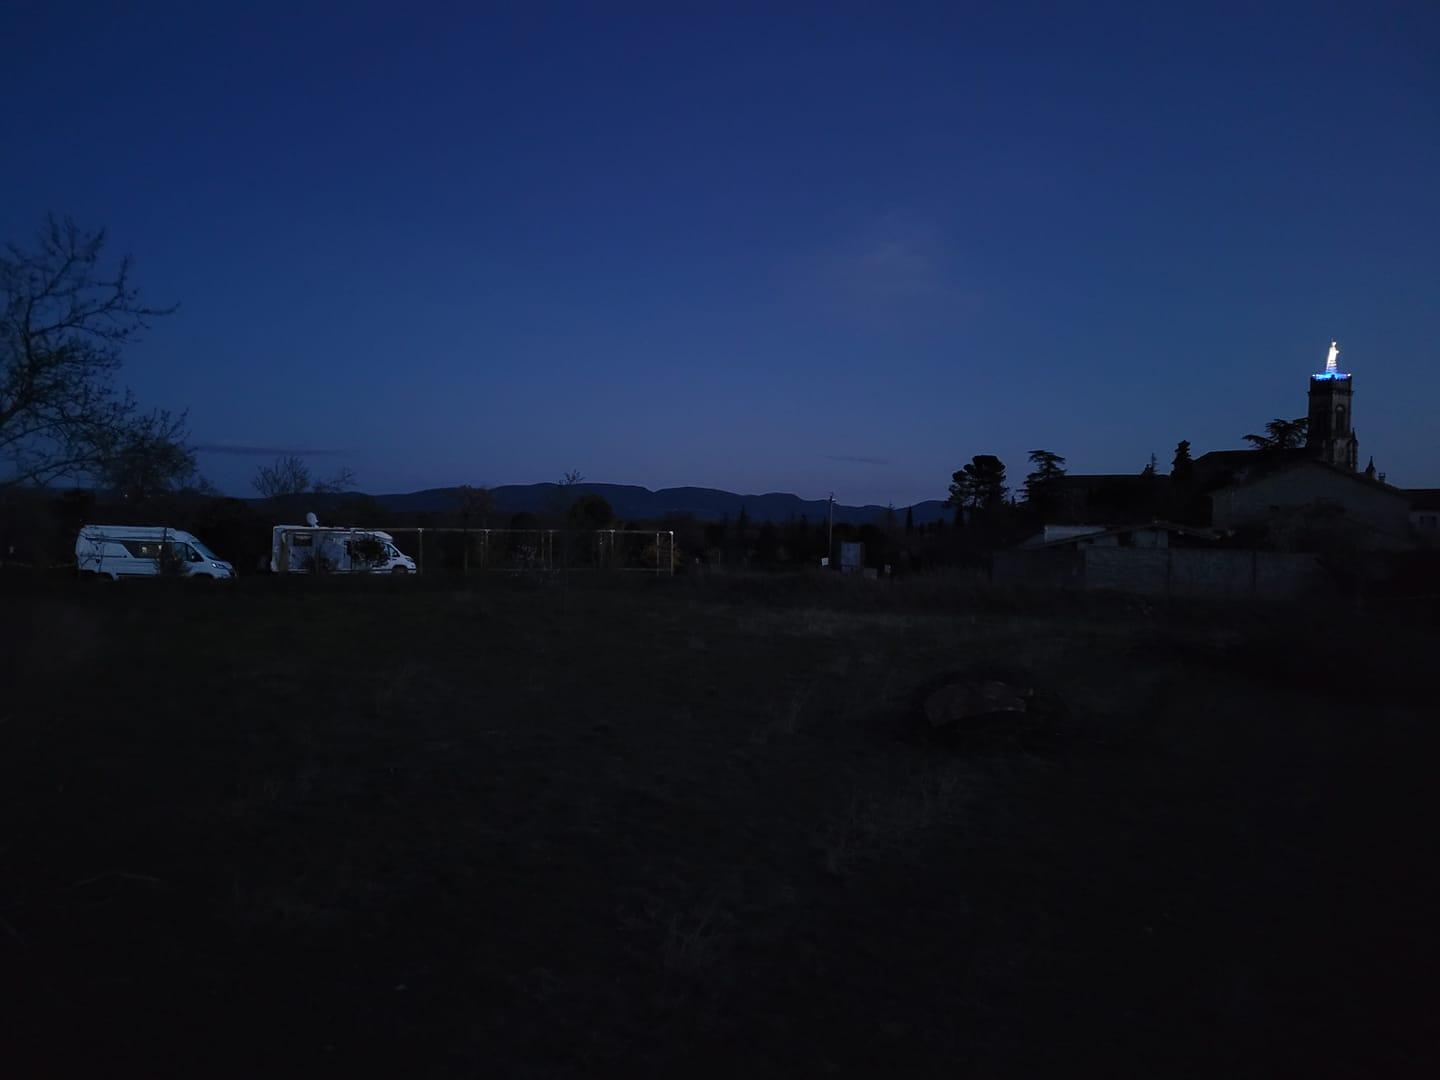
0,577,1440,1077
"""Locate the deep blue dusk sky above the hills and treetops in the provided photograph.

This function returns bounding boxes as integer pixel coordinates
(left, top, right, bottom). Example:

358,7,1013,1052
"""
0,0,1440,505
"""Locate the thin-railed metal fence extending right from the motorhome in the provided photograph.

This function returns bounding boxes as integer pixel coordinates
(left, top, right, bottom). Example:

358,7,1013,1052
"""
383,526,680,576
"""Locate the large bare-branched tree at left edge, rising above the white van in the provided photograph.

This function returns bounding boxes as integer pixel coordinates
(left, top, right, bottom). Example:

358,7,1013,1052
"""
0,217,194,487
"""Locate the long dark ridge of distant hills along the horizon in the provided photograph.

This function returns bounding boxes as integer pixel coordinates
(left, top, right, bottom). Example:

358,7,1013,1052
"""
365,484,950,526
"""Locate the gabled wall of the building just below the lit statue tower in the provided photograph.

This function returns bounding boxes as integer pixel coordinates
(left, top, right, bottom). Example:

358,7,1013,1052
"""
1210,462,1410,536
